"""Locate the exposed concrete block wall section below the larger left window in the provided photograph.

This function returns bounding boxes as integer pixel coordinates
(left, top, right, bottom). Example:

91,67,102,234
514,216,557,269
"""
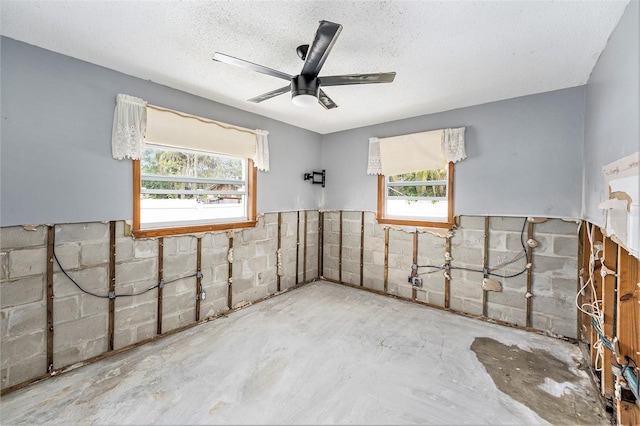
0,211,319,389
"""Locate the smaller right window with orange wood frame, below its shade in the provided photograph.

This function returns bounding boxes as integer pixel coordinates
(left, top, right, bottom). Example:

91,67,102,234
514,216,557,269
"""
378,163,453,228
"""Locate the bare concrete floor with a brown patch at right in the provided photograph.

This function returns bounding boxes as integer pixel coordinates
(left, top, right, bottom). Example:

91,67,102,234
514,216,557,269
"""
0,282,609,425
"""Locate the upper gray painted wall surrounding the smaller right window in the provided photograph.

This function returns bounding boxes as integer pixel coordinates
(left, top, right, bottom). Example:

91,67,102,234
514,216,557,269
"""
322,86,585,218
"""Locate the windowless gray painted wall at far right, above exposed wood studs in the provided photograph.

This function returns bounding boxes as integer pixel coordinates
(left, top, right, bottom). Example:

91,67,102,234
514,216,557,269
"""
583,1,640,226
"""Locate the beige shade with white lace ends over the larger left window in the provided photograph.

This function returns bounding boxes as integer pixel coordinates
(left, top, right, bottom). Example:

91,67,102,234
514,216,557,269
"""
112,95,269,171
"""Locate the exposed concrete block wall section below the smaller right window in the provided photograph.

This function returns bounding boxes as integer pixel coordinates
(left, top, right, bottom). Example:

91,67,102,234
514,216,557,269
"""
321,211,578,338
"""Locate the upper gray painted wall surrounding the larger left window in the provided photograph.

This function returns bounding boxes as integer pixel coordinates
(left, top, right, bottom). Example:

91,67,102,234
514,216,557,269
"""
0,37,322,226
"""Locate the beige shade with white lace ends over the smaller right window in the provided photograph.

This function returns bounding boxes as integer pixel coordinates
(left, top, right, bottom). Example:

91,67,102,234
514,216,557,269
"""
367,127,466,176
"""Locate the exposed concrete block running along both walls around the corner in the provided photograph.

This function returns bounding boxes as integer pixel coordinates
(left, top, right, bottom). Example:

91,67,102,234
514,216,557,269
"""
0,210,578,389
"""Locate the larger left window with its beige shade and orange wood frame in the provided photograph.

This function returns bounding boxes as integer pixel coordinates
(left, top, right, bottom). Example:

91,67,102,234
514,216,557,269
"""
133,105,257,237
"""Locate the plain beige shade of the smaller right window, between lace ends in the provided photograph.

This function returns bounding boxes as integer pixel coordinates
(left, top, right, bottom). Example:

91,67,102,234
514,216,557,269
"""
380,129,445,176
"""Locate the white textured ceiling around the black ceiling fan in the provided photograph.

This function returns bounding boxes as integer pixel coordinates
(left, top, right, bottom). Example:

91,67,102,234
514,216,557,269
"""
0,0,628,134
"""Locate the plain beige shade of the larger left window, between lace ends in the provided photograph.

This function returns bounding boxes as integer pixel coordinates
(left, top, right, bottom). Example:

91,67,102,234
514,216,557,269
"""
145,105,256,158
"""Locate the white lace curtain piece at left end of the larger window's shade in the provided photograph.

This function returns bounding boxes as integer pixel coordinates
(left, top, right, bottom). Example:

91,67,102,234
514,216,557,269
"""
111,95,147,160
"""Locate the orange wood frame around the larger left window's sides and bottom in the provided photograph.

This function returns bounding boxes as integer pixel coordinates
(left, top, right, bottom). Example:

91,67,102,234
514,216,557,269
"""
131,158,258,238
